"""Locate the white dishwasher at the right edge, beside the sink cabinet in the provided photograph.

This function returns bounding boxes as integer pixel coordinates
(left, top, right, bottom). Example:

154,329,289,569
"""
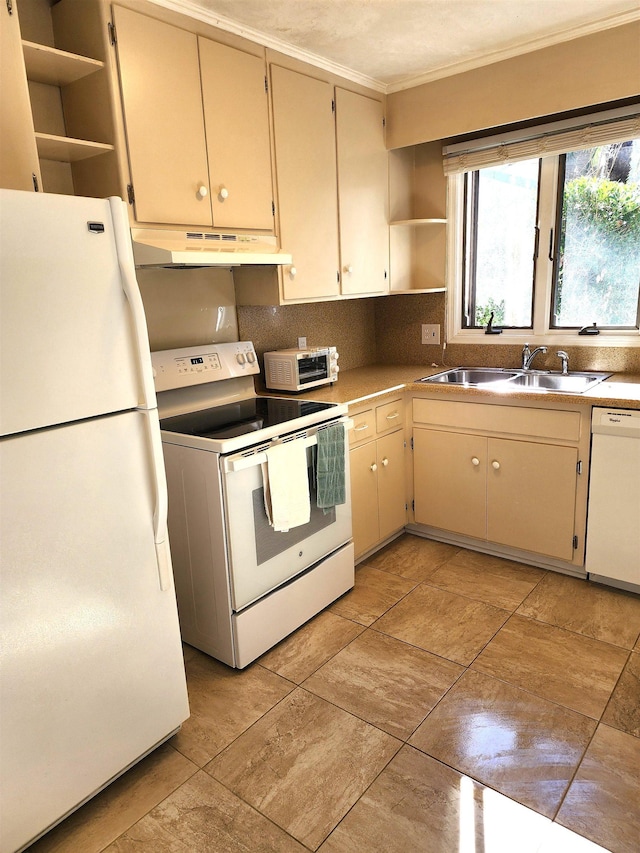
585,408,640,592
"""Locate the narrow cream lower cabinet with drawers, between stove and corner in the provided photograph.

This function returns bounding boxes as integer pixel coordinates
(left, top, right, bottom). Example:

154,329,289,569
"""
349,400,407,558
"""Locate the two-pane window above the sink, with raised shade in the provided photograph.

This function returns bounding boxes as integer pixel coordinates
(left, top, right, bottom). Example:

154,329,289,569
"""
445,108,640,343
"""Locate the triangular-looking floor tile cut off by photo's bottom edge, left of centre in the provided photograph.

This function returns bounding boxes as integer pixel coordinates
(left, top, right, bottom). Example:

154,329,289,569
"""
107,770,305,853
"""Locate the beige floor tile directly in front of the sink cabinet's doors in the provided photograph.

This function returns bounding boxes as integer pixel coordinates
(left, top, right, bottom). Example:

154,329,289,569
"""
428,551,545,610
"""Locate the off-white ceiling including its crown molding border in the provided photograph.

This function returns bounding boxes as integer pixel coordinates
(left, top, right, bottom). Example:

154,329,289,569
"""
160,0,640,91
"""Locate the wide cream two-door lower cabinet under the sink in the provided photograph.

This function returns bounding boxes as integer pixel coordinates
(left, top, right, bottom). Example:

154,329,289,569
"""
413,400,588,563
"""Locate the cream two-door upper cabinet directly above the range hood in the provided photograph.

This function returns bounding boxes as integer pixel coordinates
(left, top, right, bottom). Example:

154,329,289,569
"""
114,7,273,231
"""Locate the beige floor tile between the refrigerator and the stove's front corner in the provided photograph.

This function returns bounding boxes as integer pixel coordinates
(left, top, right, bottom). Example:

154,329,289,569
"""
171,652,293,767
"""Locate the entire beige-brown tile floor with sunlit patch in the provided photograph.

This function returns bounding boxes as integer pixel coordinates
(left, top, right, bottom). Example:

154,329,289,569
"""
26,534,640,853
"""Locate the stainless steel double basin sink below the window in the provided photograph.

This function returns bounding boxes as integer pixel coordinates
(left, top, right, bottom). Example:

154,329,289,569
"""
417,367,611,394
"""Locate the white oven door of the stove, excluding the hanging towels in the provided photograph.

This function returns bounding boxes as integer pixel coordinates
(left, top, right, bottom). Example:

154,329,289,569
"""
221,419,351,612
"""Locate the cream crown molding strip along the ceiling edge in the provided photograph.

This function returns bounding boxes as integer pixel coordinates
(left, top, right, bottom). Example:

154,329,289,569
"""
149,0,640,94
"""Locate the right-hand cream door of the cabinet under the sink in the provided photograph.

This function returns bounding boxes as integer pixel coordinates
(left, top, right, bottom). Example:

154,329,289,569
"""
487,438,578,560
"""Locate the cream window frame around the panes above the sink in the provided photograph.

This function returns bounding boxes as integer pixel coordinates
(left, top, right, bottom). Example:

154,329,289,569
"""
445,155,640,347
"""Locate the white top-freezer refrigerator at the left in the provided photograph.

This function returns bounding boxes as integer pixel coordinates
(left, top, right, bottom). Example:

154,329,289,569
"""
0,190,189,853
